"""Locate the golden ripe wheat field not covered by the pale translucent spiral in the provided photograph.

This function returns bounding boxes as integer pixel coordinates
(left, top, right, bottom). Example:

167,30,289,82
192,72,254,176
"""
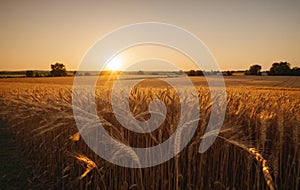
0,77,300,189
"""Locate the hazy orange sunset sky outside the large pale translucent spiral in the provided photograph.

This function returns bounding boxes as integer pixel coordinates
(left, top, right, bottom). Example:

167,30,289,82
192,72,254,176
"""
0,0,300,70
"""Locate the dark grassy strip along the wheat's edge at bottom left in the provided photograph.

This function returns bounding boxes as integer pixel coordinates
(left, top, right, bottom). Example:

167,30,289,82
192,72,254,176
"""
0,119,30,190
